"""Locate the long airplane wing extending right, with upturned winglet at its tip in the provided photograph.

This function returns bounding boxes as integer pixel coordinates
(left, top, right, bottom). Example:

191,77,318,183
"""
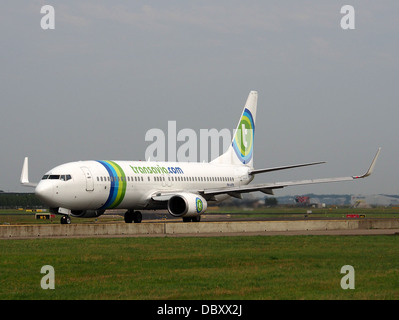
200,148,381,199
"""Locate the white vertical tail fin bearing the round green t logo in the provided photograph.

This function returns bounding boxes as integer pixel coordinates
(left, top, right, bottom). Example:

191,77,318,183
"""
211,91,258,167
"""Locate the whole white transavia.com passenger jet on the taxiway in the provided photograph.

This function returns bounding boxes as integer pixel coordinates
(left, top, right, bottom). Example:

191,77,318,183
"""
20,91,381,224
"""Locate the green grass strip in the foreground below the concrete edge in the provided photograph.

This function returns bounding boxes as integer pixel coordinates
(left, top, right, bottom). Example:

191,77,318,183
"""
0,236,399,299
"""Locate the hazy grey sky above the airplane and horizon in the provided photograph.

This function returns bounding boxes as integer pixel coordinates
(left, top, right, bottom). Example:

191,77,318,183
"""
0,0,399,196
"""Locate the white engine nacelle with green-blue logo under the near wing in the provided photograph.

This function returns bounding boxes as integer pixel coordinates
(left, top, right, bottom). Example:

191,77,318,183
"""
168,192,208,217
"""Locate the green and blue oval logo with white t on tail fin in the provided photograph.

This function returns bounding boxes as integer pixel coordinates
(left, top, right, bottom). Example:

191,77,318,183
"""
233,108,255,164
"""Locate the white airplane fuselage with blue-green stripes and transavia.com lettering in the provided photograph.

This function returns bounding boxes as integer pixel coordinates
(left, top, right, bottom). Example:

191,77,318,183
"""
35,161,253,210
